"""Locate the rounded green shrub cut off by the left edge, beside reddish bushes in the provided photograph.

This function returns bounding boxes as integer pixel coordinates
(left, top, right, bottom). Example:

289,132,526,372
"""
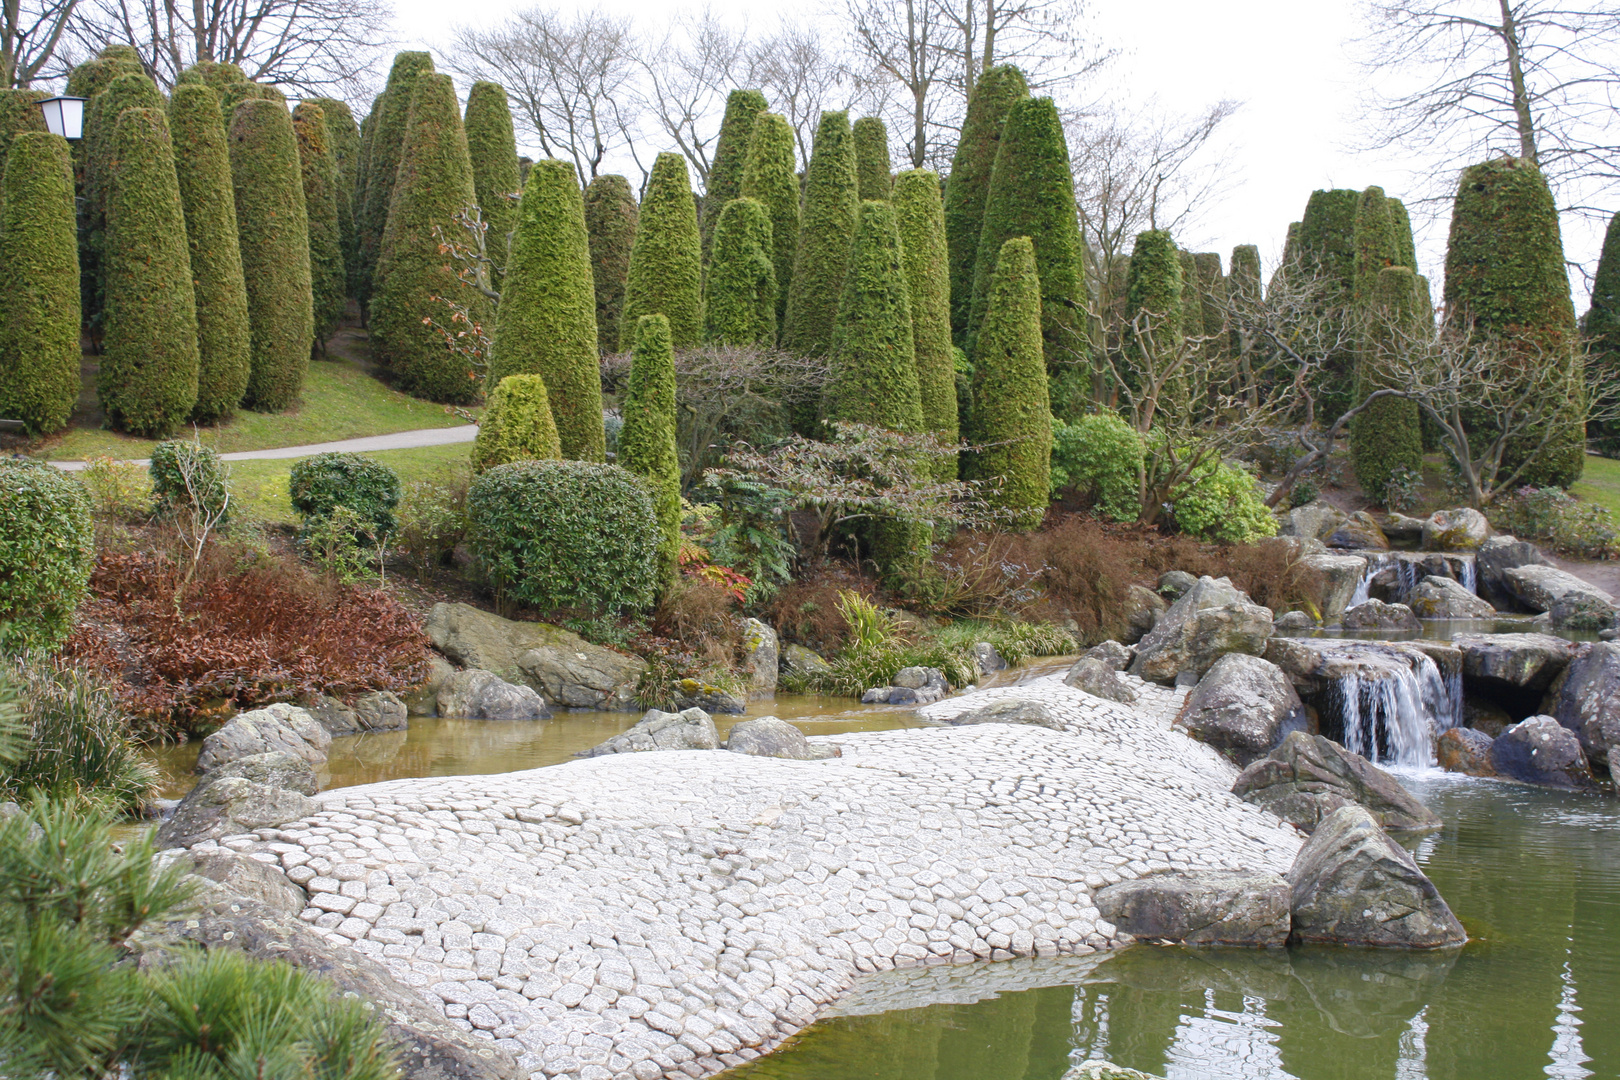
0,458,96,654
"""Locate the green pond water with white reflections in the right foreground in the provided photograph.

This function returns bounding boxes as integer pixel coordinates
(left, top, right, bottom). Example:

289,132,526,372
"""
727,774,1620,1080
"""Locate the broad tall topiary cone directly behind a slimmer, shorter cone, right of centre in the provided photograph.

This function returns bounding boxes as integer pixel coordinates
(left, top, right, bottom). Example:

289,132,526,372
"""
967,97,1090,416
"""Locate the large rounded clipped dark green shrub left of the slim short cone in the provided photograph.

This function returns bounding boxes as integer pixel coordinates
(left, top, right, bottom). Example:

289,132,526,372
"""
467,461,659,614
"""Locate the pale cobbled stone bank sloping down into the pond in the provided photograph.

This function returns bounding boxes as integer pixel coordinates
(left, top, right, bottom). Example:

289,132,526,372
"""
164,675,1301,1080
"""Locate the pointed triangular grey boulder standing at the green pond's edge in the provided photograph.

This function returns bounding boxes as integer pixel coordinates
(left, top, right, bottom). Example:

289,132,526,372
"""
1288,806,1468,949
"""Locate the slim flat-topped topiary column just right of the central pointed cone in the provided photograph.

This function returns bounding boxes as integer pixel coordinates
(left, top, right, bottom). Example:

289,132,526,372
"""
894,168,957,476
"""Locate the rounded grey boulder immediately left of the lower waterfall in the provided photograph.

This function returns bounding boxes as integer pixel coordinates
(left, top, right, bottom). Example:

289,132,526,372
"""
1176,653,1307,766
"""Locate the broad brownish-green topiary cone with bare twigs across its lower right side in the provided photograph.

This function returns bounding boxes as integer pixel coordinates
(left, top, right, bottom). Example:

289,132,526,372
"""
371,74,491,402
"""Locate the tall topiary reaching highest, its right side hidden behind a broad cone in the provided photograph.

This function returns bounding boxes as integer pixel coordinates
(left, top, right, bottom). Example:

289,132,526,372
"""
944,63,1029,343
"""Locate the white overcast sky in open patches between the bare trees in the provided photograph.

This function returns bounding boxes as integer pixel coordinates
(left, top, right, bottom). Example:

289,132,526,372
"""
382,0,1602,313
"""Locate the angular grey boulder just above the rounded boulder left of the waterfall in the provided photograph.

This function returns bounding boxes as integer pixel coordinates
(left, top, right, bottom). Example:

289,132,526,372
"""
1131,578,1272,683
